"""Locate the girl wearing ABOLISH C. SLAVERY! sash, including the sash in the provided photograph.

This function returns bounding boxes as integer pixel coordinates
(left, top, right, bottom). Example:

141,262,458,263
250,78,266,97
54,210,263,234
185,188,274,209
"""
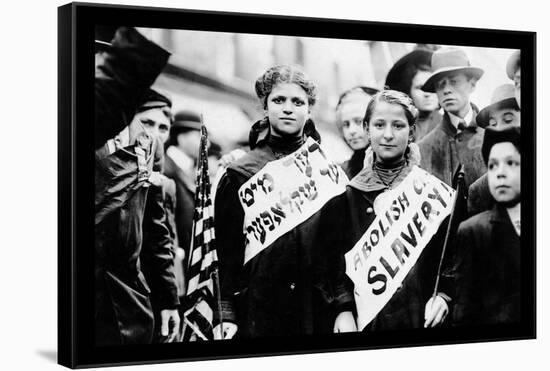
319,90,454,331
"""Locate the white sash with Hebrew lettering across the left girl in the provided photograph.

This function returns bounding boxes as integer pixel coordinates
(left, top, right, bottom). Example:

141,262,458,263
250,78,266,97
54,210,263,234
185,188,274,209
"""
238,138,348,264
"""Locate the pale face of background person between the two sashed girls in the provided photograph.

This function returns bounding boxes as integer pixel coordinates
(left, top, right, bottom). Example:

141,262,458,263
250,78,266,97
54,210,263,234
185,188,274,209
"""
337,96,370,151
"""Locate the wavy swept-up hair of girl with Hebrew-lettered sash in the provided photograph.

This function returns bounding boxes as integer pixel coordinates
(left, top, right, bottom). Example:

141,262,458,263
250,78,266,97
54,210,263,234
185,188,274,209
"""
255,65,317,109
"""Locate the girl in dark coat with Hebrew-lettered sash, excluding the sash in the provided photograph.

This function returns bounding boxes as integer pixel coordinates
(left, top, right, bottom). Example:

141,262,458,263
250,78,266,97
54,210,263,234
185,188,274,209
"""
214,65,352,338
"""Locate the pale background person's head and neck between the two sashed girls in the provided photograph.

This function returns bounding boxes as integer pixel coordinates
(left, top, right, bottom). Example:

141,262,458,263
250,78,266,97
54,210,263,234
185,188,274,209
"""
336,86,378,179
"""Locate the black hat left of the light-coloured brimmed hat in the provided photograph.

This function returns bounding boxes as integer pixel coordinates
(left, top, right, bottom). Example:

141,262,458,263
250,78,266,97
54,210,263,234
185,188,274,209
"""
386,49,433,94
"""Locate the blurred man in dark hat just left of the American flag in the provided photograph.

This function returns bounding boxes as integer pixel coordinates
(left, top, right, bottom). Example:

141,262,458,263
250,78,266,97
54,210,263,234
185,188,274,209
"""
164,110,206,295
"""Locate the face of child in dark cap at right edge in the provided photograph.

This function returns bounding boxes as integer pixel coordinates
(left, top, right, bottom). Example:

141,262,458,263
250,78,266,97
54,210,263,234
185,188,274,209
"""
487,142,521,203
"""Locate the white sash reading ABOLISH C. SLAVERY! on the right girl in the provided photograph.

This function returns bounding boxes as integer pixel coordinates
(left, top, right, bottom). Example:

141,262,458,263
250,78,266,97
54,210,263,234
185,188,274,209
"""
345,166,455,330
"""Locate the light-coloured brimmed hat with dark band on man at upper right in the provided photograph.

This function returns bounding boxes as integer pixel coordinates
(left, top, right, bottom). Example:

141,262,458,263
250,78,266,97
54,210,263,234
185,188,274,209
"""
422,48,483,93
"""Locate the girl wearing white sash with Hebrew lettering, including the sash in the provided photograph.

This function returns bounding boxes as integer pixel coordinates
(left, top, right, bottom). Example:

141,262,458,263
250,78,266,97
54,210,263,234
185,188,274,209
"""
214,65,351,339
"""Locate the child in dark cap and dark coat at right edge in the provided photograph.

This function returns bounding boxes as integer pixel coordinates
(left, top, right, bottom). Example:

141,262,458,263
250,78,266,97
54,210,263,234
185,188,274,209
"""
453,127,521,325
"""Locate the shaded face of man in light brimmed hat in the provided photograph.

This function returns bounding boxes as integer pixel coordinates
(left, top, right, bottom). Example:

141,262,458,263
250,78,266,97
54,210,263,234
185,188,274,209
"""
435,72,475,117
